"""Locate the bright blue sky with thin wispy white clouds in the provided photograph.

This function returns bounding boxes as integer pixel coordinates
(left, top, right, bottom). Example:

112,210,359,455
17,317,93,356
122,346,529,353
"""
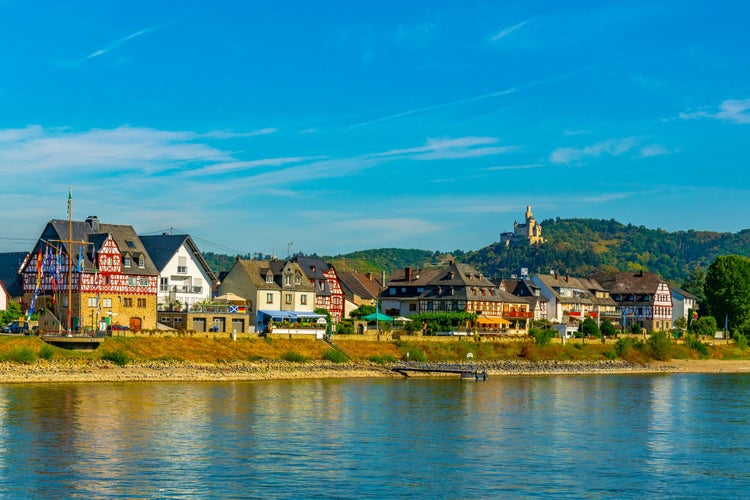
0,0,750,257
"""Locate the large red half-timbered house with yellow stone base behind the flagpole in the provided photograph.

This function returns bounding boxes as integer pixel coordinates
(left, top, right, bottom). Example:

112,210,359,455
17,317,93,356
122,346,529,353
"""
22,216,159,332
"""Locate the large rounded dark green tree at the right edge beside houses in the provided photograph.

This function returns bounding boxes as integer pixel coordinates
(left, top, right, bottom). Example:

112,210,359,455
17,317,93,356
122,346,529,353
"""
704,255,750,330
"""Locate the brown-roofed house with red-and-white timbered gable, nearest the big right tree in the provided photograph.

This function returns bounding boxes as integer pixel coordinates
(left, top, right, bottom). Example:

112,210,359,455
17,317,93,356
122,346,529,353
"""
593,271,672,333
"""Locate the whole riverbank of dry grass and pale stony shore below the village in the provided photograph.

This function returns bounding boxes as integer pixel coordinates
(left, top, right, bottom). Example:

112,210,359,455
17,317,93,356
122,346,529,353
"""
0,336,750,383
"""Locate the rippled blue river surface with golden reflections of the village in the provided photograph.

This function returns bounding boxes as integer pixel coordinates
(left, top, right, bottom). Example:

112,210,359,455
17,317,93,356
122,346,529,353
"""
0,374,750,499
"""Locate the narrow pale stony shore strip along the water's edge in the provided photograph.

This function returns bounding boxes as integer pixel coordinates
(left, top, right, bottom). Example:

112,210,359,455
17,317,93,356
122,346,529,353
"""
0,359,750,383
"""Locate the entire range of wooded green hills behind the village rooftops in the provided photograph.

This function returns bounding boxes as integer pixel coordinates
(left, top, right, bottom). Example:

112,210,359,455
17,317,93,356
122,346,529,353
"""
204,219,750,284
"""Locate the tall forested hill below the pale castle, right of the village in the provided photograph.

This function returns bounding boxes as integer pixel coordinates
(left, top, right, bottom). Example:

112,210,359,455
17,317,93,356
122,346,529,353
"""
464,218,750,283
